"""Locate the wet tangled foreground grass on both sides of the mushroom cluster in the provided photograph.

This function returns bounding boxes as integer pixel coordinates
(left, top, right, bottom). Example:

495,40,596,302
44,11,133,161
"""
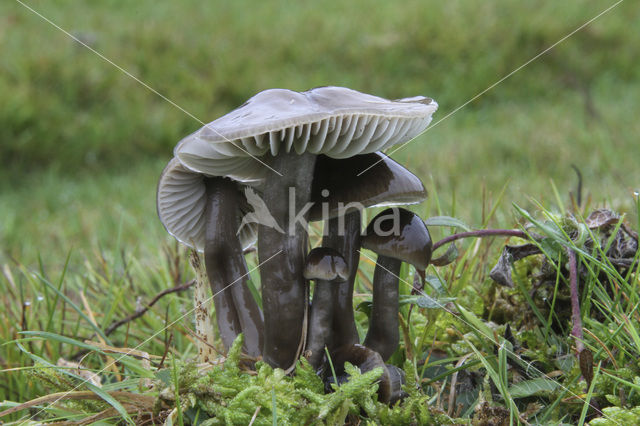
1,191,640,424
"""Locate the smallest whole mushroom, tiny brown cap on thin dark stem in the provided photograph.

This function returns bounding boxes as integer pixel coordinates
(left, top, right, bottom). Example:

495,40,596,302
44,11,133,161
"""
304,247,350,369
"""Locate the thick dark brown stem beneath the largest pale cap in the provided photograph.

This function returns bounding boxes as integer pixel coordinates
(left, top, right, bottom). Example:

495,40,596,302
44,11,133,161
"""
258,152,316,370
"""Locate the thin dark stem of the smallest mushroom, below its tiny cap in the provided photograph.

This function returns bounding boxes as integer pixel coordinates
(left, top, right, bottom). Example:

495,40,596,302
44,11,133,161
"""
305,280,338,369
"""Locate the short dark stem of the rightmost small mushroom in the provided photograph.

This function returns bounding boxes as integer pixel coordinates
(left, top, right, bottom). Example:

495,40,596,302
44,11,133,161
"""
364,255,402,361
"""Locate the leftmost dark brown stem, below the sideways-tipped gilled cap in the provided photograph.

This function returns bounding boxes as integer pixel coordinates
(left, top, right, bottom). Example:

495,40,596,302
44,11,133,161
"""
204,178,263,357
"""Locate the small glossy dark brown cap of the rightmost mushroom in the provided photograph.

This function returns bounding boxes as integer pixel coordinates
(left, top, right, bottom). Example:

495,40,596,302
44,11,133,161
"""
361,207,433,270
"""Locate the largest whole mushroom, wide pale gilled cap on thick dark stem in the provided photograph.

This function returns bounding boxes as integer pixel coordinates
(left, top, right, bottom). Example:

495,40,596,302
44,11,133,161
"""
175,87,437,369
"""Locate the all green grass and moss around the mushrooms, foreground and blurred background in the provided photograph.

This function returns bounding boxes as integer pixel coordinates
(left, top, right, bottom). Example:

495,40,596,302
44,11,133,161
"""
0,0,640,425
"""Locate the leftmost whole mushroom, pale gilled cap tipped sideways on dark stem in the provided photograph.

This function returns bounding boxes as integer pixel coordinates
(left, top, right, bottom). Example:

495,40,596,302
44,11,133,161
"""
157,158,263,357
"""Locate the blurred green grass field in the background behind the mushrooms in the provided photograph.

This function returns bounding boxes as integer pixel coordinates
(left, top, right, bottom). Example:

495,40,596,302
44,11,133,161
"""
0,0,640,263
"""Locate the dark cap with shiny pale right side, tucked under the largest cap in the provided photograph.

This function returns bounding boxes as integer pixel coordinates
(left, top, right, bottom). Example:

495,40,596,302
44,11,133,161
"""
309,152,427,221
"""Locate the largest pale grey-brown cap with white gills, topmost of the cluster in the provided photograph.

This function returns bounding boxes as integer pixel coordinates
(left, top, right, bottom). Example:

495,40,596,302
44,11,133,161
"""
174,87,438,185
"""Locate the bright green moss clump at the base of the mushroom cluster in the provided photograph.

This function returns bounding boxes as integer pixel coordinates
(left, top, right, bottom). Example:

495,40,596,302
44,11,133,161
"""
156,336,464,426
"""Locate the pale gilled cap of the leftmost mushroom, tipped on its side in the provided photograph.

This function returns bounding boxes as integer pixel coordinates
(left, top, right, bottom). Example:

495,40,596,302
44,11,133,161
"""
156,158,257,252
